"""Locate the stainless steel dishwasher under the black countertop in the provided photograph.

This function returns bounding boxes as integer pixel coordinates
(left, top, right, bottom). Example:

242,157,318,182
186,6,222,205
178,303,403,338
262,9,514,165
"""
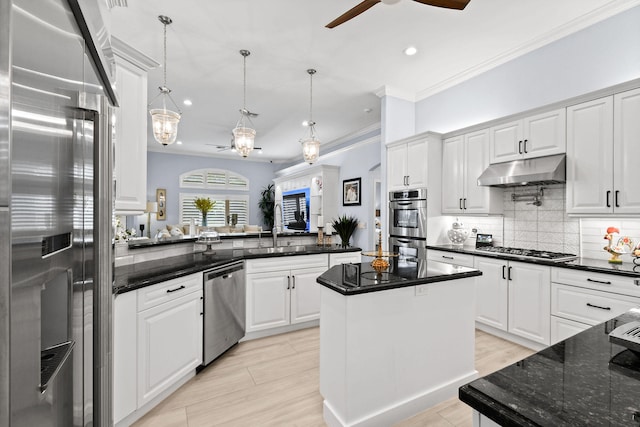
202,261,246,365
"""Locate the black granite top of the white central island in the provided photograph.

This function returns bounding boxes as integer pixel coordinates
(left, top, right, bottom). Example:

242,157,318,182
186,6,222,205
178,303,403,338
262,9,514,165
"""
316,260,482,295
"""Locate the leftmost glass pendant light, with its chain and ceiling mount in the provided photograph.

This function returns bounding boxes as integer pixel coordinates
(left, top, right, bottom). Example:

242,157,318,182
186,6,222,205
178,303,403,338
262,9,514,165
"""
149,15,182,145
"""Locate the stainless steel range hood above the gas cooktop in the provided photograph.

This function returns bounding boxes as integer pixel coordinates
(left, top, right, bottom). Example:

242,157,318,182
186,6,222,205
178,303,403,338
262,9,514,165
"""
478,154,566,187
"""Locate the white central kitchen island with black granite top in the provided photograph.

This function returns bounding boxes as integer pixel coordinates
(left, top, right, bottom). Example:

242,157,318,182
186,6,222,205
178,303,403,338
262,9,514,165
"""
317,260,482,426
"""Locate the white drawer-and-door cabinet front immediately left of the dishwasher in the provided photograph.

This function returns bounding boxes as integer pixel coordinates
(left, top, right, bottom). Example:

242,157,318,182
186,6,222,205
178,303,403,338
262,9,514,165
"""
136,274,203,408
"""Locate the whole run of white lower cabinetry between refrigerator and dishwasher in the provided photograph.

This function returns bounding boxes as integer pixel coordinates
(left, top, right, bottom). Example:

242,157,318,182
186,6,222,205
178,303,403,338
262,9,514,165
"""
113,273,202,425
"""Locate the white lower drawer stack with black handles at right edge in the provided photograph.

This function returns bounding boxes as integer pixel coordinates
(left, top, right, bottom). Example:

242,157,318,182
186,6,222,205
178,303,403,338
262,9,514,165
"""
551,267,640,344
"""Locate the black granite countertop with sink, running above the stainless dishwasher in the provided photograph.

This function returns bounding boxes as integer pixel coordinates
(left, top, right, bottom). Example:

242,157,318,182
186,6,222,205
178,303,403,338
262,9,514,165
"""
113,245,361,294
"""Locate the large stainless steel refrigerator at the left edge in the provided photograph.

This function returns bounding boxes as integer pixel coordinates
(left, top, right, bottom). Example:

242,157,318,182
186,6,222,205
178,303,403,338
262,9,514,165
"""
0,0,115,427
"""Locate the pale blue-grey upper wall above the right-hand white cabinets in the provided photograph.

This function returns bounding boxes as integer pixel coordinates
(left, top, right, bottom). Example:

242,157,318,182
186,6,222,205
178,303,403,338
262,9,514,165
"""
415,7,640,133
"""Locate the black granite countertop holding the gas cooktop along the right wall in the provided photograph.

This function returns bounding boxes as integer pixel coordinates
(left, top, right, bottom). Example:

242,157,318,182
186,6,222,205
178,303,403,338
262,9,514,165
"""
427,245,640,277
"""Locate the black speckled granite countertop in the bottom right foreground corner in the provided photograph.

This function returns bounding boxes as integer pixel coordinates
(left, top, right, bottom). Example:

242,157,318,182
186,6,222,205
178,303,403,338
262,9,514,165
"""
459,309,640,427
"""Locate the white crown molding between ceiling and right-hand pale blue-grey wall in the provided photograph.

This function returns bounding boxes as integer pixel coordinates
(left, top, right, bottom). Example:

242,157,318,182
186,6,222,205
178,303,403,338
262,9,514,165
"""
416,0,640,102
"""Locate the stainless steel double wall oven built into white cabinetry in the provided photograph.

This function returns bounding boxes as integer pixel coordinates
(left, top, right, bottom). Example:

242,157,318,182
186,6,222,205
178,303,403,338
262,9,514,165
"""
389,188,427,266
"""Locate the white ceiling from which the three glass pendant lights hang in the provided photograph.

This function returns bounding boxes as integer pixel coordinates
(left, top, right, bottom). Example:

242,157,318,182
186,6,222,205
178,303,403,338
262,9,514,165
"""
110,0,639,163
